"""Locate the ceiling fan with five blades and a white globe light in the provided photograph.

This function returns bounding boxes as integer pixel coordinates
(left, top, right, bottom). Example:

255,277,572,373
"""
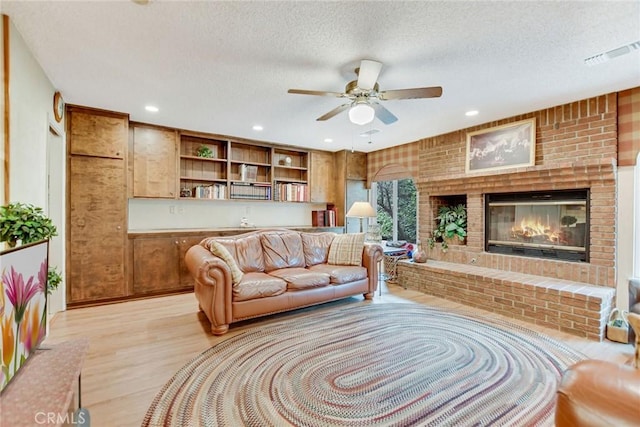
288,59,442,125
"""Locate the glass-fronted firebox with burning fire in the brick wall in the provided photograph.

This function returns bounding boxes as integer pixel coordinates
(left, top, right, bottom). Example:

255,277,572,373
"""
485,190,589,262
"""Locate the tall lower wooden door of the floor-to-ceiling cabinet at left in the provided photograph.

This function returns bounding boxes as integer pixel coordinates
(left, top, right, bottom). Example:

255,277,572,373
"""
67,156,127,303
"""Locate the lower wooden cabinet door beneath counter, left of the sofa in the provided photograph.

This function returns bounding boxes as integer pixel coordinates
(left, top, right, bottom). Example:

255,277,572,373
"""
133,237,182,295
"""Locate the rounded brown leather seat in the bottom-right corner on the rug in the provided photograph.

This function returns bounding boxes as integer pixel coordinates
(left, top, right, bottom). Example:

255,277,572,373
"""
555,360,640,427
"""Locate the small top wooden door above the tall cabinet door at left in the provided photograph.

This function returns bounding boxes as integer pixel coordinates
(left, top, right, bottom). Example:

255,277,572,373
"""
68,108,129,159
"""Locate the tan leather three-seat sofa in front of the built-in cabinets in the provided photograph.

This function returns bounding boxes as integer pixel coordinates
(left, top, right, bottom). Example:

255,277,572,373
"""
185,229,383,335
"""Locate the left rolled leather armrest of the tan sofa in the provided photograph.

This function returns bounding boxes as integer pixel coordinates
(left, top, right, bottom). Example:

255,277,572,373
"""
184,245,233,335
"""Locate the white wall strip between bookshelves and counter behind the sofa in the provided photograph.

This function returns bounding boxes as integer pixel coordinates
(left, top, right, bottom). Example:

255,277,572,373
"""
129,199,327,231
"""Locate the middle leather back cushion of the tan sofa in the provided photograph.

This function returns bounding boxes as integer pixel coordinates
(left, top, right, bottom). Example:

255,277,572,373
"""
260,231,304,273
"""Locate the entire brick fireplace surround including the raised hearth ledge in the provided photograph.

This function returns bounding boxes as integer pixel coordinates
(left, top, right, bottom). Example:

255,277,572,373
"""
398,94,617,340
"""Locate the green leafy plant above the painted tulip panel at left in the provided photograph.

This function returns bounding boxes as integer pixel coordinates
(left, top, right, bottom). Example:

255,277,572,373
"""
0,202,58,248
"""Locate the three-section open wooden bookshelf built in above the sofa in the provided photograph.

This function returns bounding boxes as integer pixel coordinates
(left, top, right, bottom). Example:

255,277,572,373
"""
180,133,310,202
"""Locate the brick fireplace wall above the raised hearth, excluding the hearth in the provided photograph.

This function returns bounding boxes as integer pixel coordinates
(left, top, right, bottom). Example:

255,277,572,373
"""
417,93,618,287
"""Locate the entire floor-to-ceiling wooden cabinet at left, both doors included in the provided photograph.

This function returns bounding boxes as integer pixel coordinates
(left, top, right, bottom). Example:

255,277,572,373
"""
66,106,129,306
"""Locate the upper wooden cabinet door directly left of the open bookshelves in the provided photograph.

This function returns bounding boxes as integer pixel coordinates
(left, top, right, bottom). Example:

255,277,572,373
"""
133,125,178,198
